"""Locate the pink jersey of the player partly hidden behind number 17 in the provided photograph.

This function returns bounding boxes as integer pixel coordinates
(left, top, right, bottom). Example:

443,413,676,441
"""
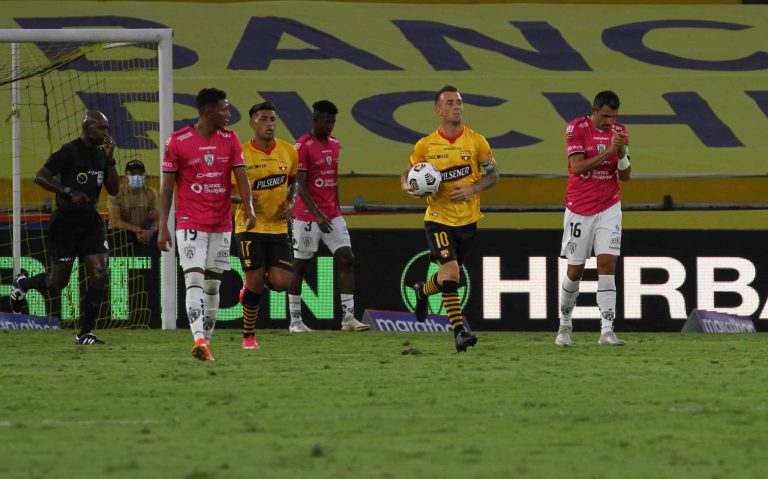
293,133,341,221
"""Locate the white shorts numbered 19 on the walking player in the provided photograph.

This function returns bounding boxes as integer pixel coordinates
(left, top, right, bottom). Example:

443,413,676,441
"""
176,230,232,272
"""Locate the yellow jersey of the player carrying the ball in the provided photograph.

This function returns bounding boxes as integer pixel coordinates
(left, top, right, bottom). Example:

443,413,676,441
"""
410,127,493,226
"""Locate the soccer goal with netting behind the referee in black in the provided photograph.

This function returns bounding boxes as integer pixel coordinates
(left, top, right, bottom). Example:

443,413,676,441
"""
0,29,175,328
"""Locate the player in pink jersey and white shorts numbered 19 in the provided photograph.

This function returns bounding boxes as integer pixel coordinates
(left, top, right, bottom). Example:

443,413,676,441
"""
157,88,256,361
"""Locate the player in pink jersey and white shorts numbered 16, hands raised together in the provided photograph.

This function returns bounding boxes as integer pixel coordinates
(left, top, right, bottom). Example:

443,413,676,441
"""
555,91,632,346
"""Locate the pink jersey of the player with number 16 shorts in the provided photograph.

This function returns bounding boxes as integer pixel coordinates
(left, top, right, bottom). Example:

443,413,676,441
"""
565,116,627,216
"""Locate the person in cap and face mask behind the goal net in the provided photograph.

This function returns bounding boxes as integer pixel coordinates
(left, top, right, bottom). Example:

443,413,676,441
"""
109,160,158,246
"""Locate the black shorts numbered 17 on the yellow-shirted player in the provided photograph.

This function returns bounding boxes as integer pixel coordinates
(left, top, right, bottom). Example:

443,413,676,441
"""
235,233,293,271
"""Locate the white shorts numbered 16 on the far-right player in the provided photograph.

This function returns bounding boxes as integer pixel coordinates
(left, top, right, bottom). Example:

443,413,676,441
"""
560,203,621,264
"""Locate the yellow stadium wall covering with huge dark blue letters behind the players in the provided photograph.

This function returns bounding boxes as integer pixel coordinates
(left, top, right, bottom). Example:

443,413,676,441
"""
0,1,768,226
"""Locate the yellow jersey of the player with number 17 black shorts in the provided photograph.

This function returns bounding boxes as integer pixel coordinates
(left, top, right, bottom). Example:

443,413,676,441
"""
232,138,299,234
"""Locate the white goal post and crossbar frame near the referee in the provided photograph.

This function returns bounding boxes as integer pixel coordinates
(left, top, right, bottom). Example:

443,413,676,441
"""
0,29,177,329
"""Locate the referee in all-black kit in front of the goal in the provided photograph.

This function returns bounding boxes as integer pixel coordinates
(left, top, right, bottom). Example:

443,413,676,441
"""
11,111,120,345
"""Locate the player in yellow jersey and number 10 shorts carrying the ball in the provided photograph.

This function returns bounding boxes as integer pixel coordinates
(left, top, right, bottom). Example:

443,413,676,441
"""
400,85,499,352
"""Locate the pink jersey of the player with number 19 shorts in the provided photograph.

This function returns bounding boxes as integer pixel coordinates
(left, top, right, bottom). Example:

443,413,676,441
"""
163,126,245,233
